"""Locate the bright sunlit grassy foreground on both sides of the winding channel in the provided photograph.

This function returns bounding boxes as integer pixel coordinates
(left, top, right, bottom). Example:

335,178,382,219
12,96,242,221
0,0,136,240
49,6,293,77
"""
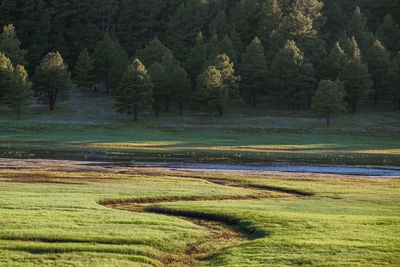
0,166,400,266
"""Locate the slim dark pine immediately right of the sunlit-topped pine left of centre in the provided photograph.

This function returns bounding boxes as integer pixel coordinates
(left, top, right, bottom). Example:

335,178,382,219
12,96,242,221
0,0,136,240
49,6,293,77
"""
148,62,169,116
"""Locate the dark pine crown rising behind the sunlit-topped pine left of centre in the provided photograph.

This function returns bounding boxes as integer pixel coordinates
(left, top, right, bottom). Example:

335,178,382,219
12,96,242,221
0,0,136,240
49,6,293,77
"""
138,37,172,66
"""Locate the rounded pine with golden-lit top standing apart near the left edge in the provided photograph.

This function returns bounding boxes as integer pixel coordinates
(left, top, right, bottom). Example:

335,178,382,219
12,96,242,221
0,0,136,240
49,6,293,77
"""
33,52,71,111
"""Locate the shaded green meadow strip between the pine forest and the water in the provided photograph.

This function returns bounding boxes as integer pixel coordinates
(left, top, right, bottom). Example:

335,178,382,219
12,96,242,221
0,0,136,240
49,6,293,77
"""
0,90,400,166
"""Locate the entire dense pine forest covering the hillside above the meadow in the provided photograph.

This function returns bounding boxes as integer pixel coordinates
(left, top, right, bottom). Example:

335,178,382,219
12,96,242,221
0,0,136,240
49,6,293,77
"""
0,0,400,123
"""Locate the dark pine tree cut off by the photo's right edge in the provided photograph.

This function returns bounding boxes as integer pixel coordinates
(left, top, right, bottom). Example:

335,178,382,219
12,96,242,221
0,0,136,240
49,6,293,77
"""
383,52,400,109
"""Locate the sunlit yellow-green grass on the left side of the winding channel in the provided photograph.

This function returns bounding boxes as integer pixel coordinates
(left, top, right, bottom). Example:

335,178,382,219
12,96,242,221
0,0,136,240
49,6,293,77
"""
0,170,274,266
